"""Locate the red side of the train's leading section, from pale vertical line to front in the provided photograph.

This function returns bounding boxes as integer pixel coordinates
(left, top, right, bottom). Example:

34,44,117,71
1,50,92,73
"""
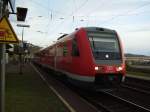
56,29,94,81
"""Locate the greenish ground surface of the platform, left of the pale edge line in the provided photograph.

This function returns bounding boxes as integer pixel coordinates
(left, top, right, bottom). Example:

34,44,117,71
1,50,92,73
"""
5,64,68,112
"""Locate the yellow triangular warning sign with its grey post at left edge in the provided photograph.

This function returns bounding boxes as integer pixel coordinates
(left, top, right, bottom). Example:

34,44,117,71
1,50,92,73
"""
0,16,19,112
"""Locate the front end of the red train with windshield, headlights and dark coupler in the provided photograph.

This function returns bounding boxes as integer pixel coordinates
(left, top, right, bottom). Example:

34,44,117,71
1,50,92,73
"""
86,28,126,85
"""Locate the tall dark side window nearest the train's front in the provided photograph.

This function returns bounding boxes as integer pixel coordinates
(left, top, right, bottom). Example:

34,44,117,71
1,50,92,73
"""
72,39,80,56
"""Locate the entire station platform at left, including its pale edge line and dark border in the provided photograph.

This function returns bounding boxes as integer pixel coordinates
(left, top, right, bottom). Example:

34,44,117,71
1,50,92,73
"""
6,63,98,112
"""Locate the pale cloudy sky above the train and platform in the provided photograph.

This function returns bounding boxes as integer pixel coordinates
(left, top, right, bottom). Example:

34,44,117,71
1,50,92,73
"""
9,0,150,56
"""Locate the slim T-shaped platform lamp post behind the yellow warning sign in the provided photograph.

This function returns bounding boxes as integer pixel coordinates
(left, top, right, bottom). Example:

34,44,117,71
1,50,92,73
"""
17,24,30,74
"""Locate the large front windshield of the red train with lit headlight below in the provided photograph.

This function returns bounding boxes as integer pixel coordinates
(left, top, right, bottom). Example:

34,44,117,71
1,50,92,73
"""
88,32,121,60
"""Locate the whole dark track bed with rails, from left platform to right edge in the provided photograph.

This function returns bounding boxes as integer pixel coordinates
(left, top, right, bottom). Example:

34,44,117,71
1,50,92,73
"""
34,63,150,112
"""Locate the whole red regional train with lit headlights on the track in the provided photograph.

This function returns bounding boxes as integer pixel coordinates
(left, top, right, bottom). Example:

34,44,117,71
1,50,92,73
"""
35,27,126,85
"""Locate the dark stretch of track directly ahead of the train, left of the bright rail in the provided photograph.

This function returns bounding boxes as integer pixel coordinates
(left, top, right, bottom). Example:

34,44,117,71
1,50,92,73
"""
80,90,150,112
